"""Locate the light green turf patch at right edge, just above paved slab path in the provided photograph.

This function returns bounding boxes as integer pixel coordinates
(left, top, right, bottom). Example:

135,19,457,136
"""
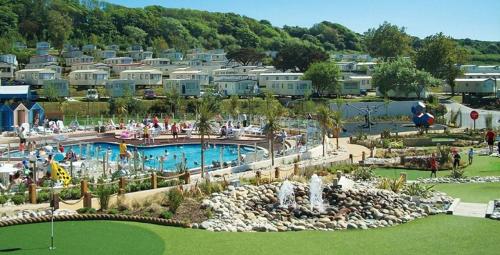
434,182,500,203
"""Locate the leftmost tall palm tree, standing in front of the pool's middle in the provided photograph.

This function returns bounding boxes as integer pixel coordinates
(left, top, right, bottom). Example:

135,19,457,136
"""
196,95,218,177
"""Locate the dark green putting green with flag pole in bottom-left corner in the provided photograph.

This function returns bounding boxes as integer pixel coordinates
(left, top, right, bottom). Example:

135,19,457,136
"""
0,221,165,255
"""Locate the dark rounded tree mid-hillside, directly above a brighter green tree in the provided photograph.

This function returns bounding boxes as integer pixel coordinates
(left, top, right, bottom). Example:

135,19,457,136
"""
274,41,328,72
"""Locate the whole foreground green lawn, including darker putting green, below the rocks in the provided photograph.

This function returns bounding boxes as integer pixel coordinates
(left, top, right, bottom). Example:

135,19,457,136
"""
0,215,500,255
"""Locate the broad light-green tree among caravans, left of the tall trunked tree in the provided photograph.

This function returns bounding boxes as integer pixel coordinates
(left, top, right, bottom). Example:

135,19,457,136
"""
372,58,436,98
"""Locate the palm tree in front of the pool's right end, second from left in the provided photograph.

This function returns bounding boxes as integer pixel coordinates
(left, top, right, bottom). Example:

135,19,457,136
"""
261,93,285,166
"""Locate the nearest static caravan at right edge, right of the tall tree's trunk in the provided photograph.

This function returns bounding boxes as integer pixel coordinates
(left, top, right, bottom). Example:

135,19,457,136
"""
452,78,500,95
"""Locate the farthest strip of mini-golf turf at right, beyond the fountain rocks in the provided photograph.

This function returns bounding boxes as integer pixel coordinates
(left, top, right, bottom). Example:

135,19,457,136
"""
374,155,500,180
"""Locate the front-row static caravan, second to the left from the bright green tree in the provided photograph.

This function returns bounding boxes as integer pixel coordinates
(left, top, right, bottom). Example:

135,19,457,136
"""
215,79,259,96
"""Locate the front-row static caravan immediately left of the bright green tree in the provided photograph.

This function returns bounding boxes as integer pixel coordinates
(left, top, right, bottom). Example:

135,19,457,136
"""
266,80,312,97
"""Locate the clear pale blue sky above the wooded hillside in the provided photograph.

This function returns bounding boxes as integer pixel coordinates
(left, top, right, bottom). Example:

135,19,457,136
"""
108,0,500,41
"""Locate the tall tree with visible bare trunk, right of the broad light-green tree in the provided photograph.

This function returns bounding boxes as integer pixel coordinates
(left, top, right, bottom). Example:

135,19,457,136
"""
416,33,468,95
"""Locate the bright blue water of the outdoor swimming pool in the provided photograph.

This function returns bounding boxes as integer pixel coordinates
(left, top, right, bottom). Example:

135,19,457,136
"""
11,143,260,171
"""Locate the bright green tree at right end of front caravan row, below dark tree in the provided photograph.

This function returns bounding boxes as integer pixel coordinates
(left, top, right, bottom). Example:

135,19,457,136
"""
302,62,341,96
